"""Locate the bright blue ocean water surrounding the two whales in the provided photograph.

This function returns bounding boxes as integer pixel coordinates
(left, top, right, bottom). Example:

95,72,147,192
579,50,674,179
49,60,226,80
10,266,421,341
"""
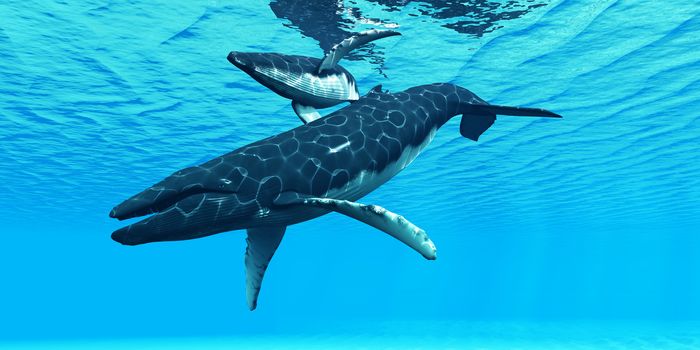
0,0,700,349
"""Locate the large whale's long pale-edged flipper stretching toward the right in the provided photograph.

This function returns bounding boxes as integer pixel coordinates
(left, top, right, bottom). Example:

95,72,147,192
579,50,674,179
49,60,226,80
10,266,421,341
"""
274,192,437,260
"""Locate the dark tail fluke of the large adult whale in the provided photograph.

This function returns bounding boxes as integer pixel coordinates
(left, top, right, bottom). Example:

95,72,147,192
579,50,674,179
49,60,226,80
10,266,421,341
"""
459,104,562,141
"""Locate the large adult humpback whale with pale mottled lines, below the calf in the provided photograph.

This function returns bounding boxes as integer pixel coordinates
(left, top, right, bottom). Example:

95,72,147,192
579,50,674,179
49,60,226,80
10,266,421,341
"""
110,84,560,310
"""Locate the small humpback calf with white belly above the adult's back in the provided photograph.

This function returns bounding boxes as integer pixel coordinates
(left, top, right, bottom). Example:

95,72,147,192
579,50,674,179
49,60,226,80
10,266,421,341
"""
227,29,401,123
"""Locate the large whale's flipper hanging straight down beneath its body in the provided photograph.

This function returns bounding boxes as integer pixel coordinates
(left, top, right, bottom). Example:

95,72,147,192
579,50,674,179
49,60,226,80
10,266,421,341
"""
245,226,287,311
